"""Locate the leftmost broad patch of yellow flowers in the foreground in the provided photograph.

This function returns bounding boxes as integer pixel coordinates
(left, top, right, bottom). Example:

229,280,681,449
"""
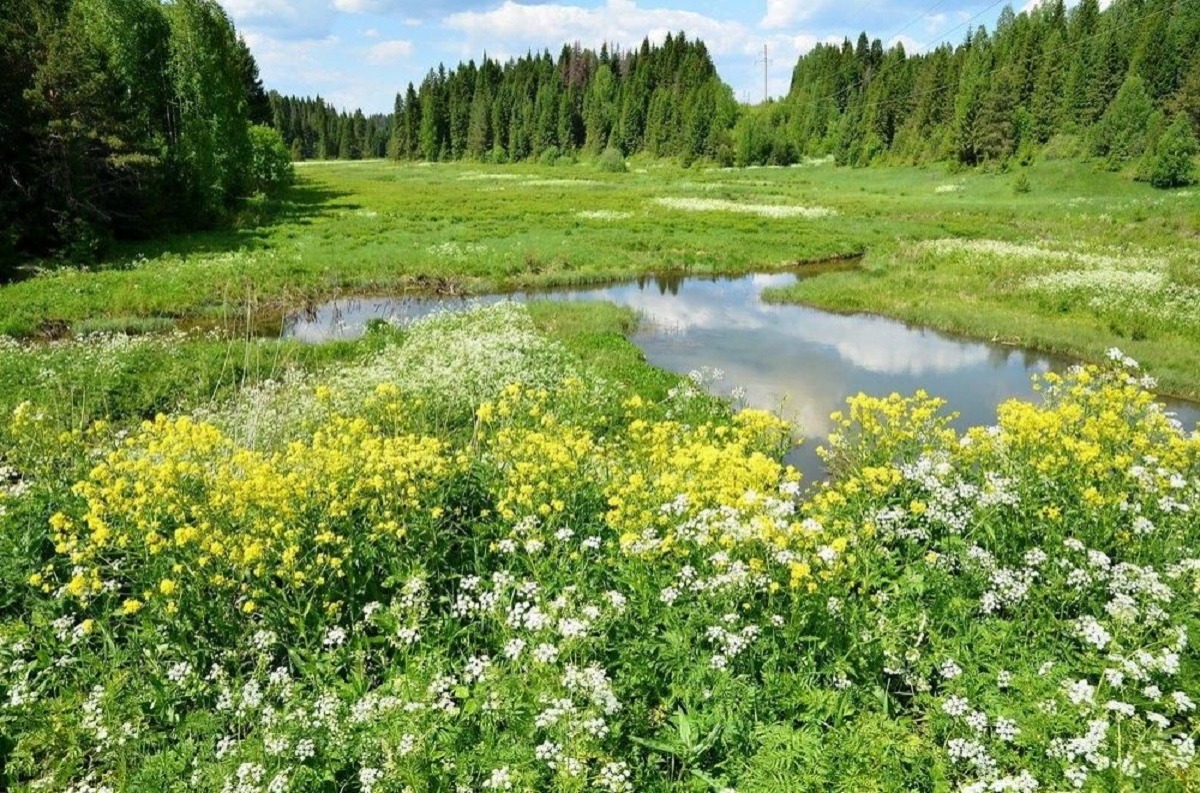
52,416,464,614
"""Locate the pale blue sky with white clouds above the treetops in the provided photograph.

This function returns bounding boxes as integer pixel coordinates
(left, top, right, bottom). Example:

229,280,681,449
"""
220,0,1024,112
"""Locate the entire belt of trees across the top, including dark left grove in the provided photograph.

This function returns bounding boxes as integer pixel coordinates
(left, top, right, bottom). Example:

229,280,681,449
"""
0,0,1200,268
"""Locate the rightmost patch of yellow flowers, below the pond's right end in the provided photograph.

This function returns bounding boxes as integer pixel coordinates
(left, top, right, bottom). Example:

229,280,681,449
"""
804,366,1200,559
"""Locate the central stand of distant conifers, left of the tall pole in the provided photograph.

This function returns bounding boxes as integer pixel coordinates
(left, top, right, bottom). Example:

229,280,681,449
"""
271,34,738,162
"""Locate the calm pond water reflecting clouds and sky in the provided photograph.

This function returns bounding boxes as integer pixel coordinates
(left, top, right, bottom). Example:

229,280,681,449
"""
284,274,1200,481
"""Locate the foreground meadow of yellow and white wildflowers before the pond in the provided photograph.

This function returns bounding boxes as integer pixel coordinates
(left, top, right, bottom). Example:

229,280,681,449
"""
0,305,1200,793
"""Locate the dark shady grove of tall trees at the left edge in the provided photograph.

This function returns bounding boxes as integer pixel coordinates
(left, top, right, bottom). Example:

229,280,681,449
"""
0,0,290,275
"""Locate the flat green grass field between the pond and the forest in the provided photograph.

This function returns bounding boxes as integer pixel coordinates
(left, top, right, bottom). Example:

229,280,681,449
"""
0,162,1200,388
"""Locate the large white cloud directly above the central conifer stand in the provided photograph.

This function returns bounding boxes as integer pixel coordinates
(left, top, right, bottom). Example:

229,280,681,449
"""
444,0,749,53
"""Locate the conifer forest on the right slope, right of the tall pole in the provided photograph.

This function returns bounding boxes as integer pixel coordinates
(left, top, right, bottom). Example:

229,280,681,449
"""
733,0,1200,168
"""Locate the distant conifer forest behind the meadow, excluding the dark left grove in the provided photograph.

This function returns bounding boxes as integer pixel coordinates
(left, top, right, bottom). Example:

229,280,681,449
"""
271,0,1200,168
